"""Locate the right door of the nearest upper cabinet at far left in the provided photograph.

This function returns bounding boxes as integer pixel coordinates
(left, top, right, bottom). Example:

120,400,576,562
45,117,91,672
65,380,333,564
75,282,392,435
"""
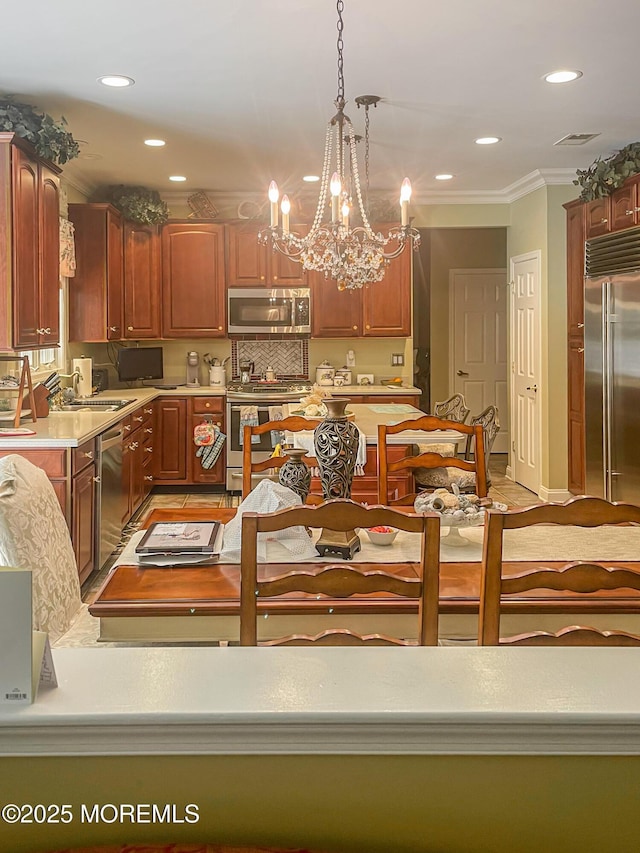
38,164,60,347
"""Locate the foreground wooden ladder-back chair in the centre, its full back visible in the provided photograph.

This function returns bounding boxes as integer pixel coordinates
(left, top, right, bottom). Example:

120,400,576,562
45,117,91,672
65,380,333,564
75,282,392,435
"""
240,498,440,646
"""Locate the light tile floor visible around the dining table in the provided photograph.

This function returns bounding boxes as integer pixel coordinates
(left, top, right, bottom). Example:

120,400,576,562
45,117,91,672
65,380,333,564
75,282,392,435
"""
82,454,538,604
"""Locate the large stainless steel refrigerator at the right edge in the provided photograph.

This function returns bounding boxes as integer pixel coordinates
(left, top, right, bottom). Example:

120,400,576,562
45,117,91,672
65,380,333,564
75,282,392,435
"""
584,270,640,503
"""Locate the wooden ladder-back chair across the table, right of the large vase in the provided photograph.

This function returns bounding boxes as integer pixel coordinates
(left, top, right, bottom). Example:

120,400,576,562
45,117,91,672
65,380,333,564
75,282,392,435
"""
378,415,487,506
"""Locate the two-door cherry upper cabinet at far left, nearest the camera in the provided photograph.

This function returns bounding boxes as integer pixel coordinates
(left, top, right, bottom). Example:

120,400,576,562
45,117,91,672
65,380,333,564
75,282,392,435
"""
0,133,60,349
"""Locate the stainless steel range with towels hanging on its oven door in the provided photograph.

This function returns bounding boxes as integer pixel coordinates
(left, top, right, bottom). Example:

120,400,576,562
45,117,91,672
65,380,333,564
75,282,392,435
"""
227,379,313,492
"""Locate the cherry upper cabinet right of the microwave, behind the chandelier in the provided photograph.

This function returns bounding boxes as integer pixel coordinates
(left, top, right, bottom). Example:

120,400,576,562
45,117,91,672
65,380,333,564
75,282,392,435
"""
310,236,411,338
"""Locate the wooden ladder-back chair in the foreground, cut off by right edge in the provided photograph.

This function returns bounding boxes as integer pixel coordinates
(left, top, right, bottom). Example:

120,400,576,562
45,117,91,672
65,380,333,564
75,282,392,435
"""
478,497,640,646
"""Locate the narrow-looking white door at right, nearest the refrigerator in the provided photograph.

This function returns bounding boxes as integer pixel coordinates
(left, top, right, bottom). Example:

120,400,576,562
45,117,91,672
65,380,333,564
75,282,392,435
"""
511,251,541,494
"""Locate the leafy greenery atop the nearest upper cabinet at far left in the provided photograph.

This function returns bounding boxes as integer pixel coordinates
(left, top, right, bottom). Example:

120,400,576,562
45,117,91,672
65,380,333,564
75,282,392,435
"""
0,95,80,165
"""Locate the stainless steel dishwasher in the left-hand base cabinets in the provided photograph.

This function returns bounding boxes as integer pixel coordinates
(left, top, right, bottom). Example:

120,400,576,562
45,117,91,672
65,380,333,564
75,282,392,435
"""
97,424,127,568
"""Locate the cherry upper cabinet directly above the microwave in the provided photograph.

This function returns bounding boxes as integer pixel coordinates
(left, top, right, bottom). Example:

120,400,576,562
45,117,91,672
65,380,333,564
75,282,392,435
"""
227,221,308,287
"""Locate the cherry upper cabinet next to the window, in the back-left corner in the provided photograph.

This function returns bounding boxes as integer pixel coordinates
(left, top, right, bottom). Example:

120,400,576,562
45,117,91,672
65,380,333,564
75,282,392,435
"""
69,204,123,343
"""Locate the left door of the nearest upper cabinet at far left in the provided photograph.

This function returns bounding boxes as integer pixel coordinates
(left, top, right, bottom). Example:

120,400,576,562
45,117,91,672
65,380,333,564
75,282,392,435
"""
12,147,40,349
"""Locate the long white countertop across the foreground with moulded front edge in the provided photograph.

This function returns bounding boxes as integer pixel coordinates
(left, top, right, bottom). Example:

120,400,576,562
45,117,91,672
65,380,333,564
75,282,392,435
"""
0,647,640,756
